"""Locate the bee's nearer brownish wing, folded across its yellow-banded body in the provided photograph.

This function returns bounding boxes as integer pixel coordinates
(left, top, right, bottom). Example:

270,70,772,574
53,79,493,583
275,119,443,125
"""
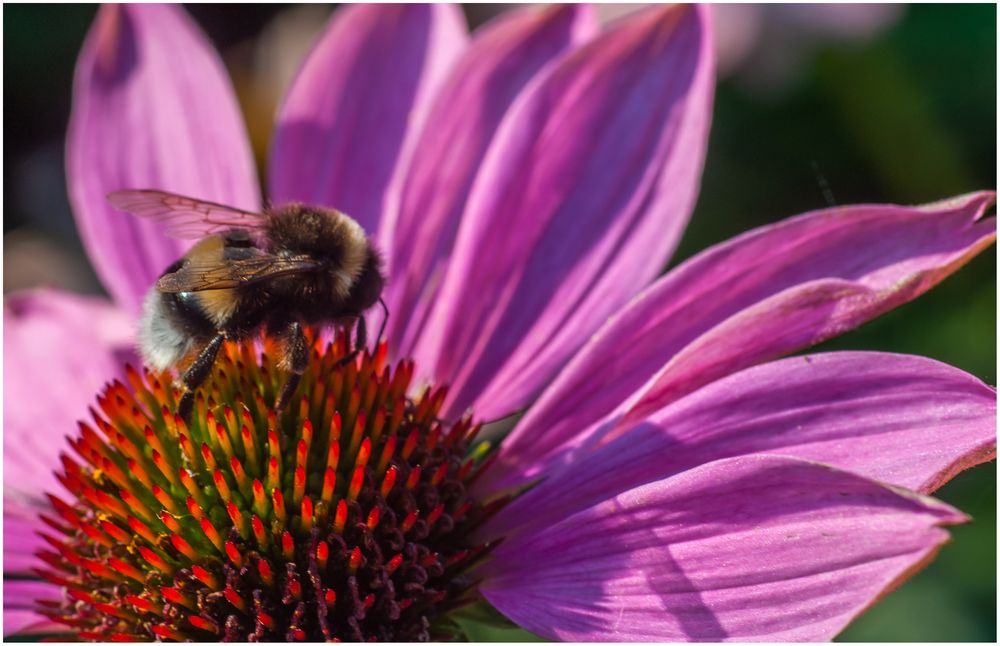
156,255,321,293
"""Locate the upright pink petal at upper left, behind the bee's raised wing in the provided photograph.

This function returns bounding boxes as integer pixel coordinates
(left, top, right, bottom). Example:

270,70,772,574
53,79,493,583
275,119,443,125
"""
66,4,260,311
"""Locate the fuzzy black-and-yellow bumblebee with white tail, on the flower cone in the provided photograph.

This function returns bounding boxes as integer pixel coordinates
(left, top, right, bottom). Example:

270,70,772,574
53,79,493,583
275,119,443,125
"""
108,190,389,421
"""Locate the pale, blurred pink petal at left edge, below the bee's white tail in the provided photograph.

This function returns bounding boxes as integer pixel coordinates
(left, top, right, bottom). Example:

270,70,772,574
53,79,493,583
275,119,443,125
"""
3,290,135,501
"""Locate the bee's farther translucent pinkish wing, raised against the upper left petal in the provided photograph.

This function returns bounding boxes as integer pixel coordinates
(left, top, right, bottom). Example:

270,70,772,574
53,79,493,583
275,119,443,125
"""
108,189,267,238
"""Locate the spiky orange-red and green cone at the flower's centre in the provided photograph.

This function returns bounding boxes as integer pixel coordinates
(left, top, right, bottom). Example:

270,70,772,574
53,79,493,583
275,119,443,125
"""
39,336,503,641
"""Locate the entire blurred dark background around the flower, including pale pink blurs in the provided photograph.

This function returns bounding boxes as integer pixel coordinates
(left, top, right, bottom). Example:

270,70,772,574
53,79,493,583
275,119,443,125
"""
3,4,997,642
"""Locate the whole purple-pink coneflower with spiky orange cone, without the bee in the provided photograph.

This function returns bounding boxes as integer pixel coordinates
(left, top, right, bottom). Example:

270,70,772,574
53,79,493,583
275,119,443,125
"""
4,5,996,641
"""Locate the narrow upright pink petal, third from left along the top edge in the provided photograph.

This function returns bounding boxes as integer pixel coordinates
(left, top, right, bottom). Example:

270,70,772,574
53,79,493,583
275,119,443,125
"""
386,5,597,356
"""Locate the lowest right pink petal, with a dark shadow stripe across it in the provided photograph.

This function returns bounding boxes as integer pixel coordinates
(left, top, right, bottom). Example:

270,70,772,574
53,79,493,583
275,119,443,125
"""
481,456,967,642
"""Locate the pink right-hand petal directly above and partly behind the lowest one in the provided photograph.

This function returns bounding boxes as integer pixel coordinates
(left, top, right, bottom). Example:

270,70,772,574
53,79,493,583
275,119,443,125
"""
484,352,996,540
